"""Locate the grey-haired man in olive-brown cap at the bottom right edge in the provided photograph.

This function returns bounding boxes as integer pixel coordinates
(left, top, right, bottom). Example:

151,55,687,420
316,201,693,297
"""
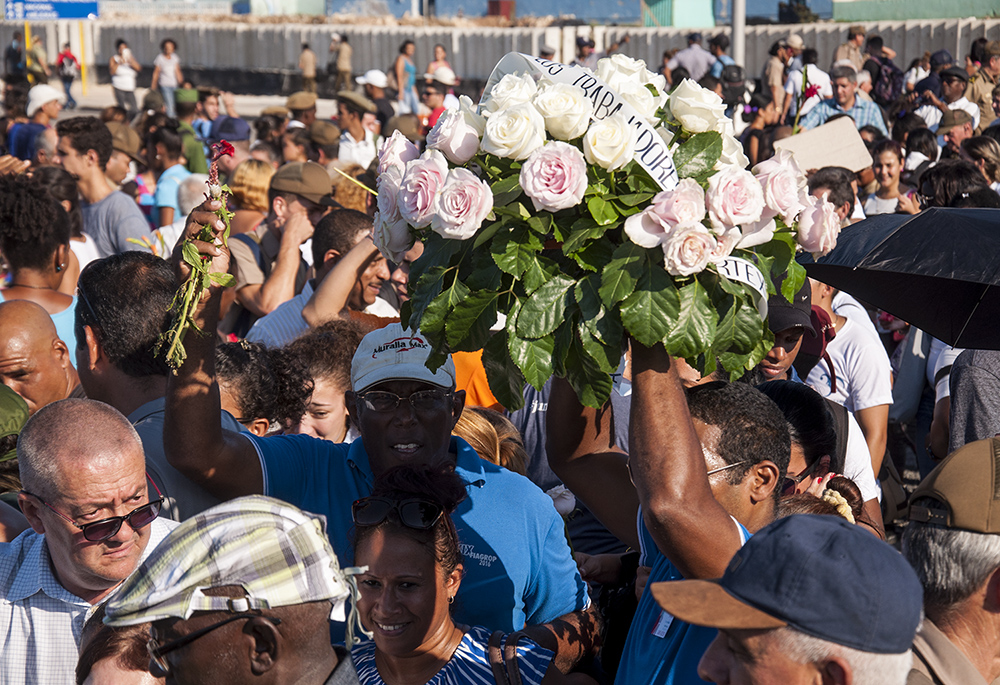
903,438,1000,685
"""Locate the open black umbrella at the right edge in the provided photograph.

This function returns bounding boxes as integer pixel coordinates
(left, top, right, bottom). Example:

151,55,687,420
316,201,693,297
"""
804,207,1000,350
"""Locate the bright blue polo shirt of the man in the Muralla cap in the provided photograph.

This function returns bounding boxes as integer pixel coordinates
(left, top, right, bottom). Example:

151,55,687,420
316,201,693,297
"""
247,434,588,632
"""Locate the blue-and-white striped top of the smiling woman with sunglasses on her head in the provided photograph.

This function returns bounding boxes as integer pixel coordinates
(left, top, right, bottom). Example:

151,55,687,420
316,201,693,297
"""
351,626,553,685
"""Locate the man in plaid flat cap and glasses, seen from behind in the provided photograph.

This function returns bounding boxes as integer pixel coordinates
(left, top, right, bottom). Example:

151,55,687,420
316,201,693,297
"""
104,496,358,685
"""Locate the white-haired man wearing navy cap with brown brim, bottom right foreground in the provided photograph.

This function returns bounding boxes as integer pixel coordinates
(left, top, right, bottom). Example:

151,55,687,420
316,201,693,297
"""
651,514,920,685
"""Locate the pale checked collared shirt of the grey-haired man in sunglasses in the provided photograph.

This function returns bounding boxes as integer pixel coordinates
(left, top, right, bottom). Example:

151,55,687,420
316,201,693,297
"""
0,518,177,685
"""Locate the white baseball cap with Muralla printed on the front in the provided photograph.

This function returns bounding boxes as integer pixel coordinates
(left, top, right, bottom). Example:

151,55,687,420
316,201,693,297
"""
351,323,455,392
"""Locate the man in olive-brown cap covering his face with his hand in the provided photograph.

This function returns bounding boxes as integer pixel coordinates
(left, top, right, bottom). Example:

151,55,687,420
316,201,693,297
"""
222,162,337,336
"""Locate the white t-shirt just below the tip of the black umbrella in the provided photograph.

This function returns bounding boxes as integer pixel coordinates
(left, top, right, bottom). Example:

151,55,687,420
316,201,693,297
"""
806,318,892,412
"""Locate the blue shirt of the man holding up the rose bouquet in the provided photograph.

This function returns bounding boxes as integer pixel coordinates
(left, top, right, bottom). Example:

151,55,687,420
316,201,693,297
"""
615,509,750,685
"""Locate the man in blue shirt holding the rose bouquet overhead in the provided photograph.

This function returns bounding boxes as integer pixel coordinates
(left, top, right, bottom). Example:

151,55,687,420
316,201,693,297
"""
548,342,790,685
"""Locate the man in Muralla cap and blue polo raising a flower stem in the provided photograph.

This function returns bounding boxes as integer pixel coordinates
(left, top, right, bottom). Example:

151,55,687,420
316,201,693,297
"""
164,203,588,656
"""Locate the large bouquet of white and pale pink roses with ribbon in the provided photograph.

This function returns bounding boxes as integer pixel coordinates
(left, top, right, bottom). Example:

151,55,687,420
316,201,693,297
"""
373,54,839,409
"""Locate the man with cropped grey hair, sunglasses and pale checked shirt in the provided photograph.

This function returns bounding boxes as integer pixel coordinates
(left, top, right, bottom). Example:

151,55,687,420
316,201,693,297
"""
0,399,175,685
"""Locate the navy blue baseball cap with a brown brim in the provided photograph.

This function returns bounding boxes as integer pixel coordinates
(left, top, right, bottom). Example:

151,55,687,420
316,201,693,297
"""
651,514,923,654
